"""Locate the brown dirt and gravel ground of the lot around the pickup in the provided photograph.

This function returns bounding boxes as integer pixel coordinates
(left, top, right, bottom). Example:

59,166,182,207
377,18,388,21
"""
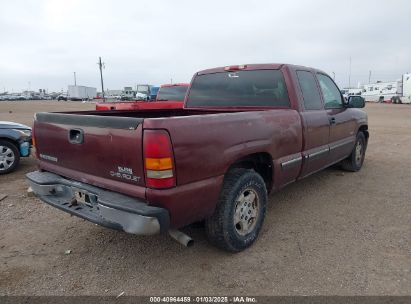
0,102,411,295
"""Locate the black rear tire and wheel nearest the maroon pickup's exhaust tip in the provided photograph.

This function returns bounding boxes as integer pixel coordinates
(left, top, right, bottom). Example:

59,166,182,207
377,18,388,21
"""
205,168,267,252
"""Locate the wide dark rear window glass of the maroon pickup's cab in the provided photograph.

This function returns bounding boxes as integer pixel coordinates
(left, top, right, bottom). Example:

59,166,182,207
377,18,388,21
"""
187,70,290,107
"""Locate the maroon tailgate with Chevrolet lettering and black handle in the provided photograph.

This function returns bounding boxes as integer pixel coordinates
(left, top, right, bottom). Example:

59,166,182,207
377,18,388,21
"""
34,113,144,196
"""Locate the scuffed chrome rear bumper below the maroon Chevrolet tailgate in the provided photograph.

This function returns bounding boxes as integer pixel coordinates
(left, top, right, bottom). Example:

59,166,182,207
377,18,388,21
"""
26,171,170,235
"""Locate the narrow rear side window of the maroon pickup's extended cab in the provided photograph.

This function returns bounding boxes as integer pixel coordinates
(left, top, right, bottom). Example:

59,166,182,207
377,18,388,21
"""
297,71,322,110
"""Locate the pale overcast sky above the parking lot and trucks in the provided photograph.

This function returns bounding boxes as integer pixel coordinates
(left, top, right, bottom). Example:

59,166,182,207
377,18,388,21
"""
0,0,411,92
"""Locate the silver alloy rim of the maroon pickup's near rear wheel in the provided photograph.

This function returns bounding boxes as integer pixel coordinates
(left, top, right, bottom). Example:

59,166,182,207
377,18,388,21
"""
234,189,260,236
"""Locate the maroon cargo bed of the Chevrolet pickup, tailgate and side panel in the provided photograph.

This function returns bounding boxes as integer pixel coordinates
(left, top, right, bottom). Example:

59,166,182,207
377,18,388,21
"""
34,109,302,226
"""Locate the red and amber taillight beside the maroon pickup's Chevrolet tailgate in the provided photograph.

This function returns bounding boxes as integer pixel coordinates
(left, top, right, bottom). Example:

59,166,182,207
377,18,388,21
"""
143,130,176,189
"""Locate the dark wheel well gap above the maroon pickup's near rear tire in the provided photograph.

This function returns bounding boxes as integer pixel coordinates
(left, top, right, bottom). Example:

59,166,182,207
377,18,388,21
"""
229,152,273,192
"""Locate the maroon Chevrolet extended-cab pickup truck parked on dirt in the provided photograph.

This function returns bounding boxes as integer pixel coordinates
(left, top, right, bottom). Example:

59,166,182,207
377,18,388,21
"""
27,64,368,252
